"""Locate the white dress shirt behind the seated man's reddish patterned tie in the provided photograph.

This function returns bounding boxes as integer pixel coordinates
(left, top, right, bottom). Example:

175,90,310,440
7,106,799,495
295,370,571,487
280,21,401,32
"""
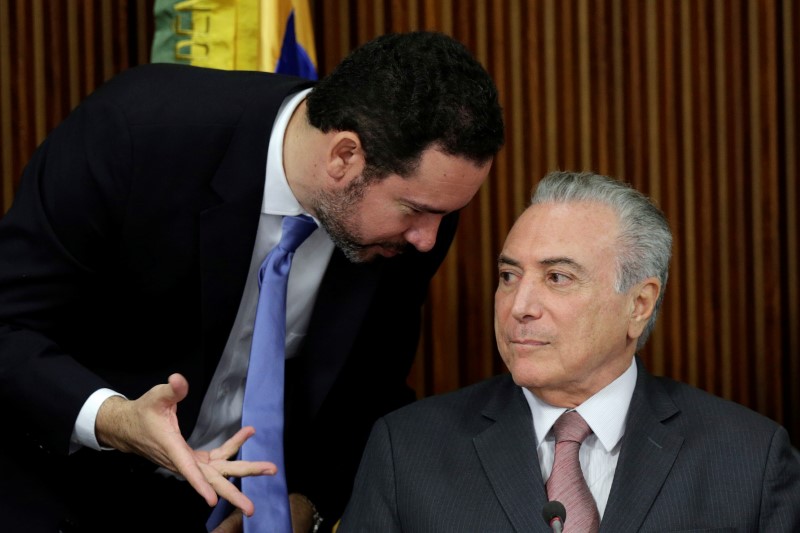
522,359,636,518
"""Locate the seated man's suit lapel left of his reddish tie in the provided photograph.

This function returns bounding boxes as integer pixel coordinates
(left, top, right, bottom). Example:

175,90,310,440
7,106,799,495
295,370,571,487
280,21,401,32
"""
473,376,548,532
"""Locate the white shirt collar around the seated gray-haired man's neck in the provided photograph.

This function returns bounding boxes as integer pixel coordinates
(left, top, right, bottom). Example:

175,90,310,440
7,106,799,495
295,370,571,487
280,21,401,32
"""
522,358,636,452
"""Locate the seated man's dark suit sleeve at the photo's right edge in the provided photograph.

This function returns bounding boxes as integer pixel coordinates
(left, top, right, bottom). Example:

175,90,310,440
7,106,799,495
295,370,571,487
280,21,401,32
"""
758,427,800,531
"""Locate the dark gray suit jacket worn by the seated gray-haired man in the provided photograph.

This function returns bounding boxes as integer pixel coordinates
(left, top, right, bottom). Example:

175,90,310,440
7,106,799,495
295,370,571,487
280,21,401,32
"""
338,361,800,533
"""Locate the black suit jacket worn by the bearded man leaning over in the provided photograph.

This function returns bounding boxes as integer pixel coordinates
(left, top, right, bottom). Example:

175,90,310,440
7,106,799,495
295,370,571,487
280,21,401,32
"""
0,64,457,531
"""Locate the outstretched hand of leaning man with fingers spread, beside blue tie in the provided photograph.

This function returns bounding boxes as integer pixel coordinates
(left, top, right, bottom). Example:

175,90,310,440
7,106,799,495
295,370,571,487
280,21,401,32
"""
95,374,277,516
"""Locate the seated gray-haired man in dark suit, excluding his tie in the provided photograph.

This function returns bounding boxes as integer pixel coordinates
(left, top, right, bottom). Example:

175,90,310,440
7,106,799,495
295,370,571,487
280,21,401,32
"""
339,172,800,533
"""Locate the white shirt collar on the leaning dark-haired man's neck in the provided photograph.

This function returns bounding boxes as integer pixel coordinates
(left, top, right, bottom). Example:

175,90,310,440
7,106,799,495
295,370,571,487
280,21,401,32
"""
261,89,311,216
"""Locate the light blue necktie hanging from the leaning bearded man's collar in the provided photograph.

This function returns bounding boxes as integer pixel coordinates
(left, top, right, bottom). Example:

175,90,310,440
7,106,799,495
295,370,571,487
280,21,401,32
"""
207,215,317,533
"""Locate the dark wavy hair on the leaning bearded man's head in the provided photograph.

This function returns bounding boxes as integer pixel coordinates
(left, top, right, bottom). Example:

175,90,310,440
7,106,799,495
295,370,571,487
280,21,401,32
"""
307,31,504,178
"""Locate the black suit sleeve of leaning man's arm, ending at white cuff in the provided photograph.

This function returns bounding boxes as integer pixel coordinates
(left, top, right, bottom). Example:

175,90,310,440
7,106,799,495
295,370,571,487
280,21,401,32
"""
0,88,129,453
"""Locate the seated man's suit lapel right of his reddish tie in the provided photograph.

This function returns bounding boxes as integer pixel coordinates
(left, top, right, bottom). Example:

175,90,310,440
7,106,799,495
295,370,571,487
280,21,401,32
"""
600,358,683,532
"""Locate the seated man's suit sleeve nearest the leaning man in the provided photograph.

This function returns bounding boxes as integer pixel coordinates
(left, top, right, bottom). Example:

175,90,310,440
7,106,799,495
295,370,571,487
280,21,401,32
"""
337,418,402,533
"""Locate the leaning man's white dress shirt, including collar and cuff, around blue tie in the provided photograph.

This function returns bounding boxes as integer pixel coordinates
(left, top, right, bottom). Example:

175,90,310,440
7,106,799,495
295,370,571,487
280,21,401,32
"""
73,89,334,454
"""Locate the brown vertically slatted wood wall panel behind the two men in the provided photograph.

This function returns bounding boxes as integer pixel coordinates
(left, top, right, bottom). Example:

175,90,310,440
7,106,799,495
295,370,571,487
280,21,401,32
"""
0,0,800,444
